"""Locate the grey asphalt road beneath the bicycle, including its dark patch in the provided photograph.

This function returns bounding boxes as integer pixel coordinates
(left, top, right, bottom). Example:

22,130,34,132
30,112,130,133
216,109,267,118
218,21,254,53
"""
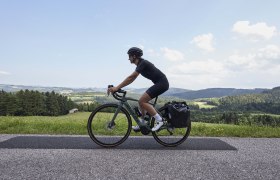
0,135,280,180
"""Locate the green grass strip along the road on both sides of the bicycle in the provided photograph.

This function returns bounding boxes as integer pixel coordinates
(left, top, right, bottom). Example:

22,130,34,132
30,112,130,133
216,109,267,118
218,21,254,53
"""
0,112,280,138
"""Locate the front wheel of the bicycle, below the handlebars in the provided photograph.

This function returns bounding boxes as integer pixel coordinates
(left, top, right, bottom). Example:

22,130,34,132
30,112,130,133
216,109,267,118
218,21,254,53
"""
87,104,132,147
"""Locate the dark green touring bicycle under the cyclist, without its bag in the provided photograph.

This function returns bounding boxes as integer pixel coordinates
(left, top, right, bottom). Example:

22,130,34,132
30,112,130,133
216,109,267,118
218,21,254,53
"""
87,86,191,147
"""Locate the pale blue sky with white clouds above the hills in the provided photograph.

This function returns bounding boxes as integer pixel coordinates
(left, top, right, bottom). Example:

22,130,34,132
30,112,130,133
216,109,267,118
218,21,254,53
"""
0,0,280,90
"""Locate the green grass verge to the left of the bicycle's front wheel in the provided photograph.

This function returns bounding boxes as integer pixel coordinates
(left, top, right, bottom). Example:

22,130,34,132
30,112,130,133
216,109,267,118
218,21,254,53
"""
0,113,89,134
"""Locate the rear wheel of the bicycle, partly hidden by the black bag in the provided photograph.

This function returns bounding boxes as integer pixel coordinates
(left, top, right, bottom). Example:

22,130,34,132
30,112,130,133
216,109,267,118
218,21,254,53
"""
151,107,191,147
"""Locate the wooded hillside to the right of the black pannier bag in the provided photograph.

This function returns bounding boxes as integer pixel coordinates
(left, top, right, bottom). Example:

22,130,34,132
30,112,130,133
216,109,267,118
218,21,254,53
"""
188,87,280,127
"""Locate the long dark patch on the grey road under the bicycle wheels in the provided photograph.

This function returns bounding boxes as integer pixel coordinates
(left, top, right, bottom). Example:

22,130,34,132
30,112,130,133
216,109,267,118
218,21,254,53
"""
0,136,237,150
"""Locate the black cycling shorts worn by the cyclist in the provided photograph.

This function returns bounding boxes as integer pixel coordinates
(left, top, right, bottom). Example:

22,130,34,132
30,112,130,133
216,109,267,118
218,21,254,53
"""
146,78,169,99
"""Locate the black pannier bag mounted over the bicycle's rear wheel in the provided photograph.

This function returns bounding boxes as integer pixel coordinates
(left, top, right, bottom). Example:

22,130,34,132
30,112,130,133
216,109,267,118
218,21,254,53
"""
166,101,190,128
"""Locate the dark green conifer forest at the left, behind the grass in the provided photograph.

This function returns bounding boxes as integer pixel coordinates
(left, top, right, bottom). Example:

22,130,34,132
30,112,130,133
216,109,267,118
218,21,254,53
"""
0,90,77,116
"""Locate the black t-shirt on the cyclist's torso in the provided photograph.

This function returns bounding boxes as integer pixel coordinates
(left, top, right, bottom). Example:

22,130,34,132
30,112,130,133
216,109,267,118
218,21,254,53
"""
135,59,166,84
